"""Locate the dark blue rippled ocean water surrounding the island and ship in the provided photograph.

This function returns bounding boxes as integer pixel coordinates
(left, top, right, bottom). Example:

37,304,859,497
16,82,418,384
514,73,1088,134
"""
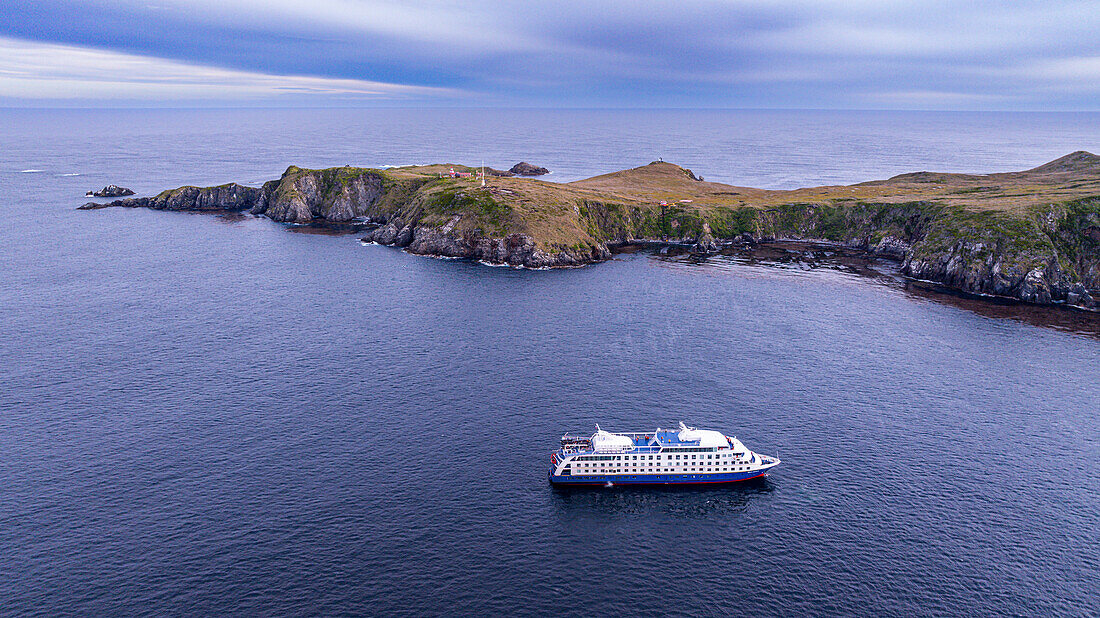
0,110,1100,616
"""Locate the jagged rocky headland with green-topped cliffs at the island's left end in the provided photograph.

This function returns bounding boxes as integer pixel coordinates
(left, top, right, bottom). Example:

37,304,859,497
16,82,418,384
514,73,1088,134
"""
80,166,611,268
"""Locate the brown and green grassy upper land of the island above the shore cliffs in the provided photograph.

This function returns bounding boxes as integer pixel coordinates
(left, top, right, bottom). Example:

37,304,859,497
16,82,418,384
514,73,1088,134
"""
332,152,1100,251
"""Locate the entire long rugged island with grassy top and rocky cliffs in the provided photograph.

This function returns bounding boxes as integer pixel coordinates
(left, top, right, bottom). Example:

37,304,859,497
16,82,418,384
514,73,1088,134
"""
80,152,1100,310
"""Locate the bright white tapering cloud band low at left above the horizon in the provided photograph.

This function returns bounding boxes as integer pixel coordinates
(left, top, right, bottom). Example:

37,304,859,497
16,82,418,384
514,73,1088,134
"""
0,38,459,100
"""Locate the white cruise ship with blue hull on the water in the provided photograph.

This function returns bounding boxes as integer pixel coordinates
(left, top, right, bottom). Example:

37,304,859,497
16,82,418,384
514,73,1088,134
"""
550,422,779,485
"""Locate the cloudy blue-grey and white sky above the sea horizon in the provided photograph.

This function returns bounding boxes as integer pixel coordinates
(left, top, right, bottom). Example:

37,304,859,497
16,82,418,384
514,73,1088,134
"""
0,0,1100,111
